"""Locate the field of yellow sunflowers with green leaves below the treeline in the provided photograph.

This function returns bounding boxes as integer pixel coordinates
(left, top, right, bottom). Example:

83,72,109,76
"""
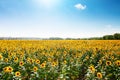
0,40,120,80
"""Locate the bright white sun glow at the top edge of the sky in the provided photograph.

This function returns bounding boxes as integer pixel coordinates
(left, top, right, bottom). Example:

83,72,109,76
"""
35,0,58,8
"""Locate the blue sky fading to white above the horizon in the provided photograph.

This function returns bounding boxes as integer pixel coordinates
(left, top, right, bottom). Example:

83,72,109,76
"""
0,0,120,38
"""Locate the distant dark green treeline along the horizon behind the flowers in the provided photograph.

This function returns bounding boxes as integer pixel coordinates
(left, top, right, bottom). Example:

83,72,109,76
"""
0,33,120,40
